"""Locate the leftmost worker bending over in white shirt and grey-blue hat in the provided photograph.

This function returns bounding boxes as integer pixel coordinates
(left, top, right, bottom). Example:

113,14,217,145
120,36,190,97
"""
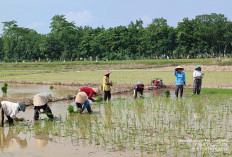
0,101,26,127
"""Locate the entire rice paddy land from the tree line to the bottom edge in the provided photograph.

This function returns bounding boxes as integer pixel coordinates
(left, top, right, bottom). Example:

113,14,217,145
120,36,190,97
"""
0,59,232,157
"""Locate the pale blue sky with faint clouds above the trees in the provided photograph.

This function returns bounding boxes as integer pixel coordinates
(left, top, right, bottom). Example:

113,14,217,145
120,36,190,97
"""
0,0,232,34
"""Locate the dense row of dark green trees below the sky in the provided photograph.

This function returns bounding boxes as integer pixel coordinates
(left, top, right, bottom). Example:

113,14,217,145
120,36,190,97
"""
0,13,232,61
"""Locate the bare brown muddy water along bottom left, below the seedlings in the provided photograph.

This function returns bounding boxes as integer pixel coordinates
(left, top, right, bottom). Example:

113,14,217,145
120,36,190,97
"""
0,128,150,157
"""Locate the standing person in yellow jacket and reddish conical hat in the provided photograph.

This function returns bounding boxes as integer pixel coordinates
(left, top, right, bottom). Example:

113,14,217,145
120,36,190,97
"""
102,70,112,101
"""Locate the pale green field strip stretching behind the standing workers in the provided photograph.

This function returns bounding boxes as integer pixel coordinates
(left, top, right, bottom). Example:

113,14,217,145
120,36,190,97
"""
0,71,232,87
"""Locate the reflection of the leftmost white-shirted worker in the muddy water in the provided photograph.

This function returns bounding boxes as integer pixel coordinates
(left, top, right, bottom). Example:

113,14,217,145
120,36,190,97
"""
0,128,27,151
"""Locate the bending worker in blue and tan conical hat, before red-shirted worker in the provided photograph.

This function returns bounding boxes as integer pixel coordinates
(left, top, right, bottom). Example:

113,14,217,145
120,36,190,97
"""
75,91,92,114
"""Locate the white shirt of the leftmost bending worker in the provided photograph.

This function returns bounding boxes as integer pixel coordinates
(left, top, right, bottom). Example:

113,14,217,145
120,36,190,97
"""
1,101,19,118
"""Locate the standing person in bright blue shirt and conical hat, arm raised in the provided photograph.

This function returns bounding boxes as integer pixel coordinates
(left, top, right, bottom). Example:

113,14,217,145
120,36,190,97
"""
174,66,186,98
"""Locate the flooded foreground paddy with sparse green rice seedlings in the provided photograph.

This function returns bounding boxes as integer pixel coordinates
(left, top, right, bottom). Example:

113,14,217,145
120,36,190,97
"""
0,86,232,157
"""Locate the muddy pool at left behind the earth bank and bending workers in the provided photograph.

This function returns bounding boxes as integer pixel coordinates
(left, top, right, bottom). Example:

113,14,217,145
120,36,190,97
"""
0,84,79,98
